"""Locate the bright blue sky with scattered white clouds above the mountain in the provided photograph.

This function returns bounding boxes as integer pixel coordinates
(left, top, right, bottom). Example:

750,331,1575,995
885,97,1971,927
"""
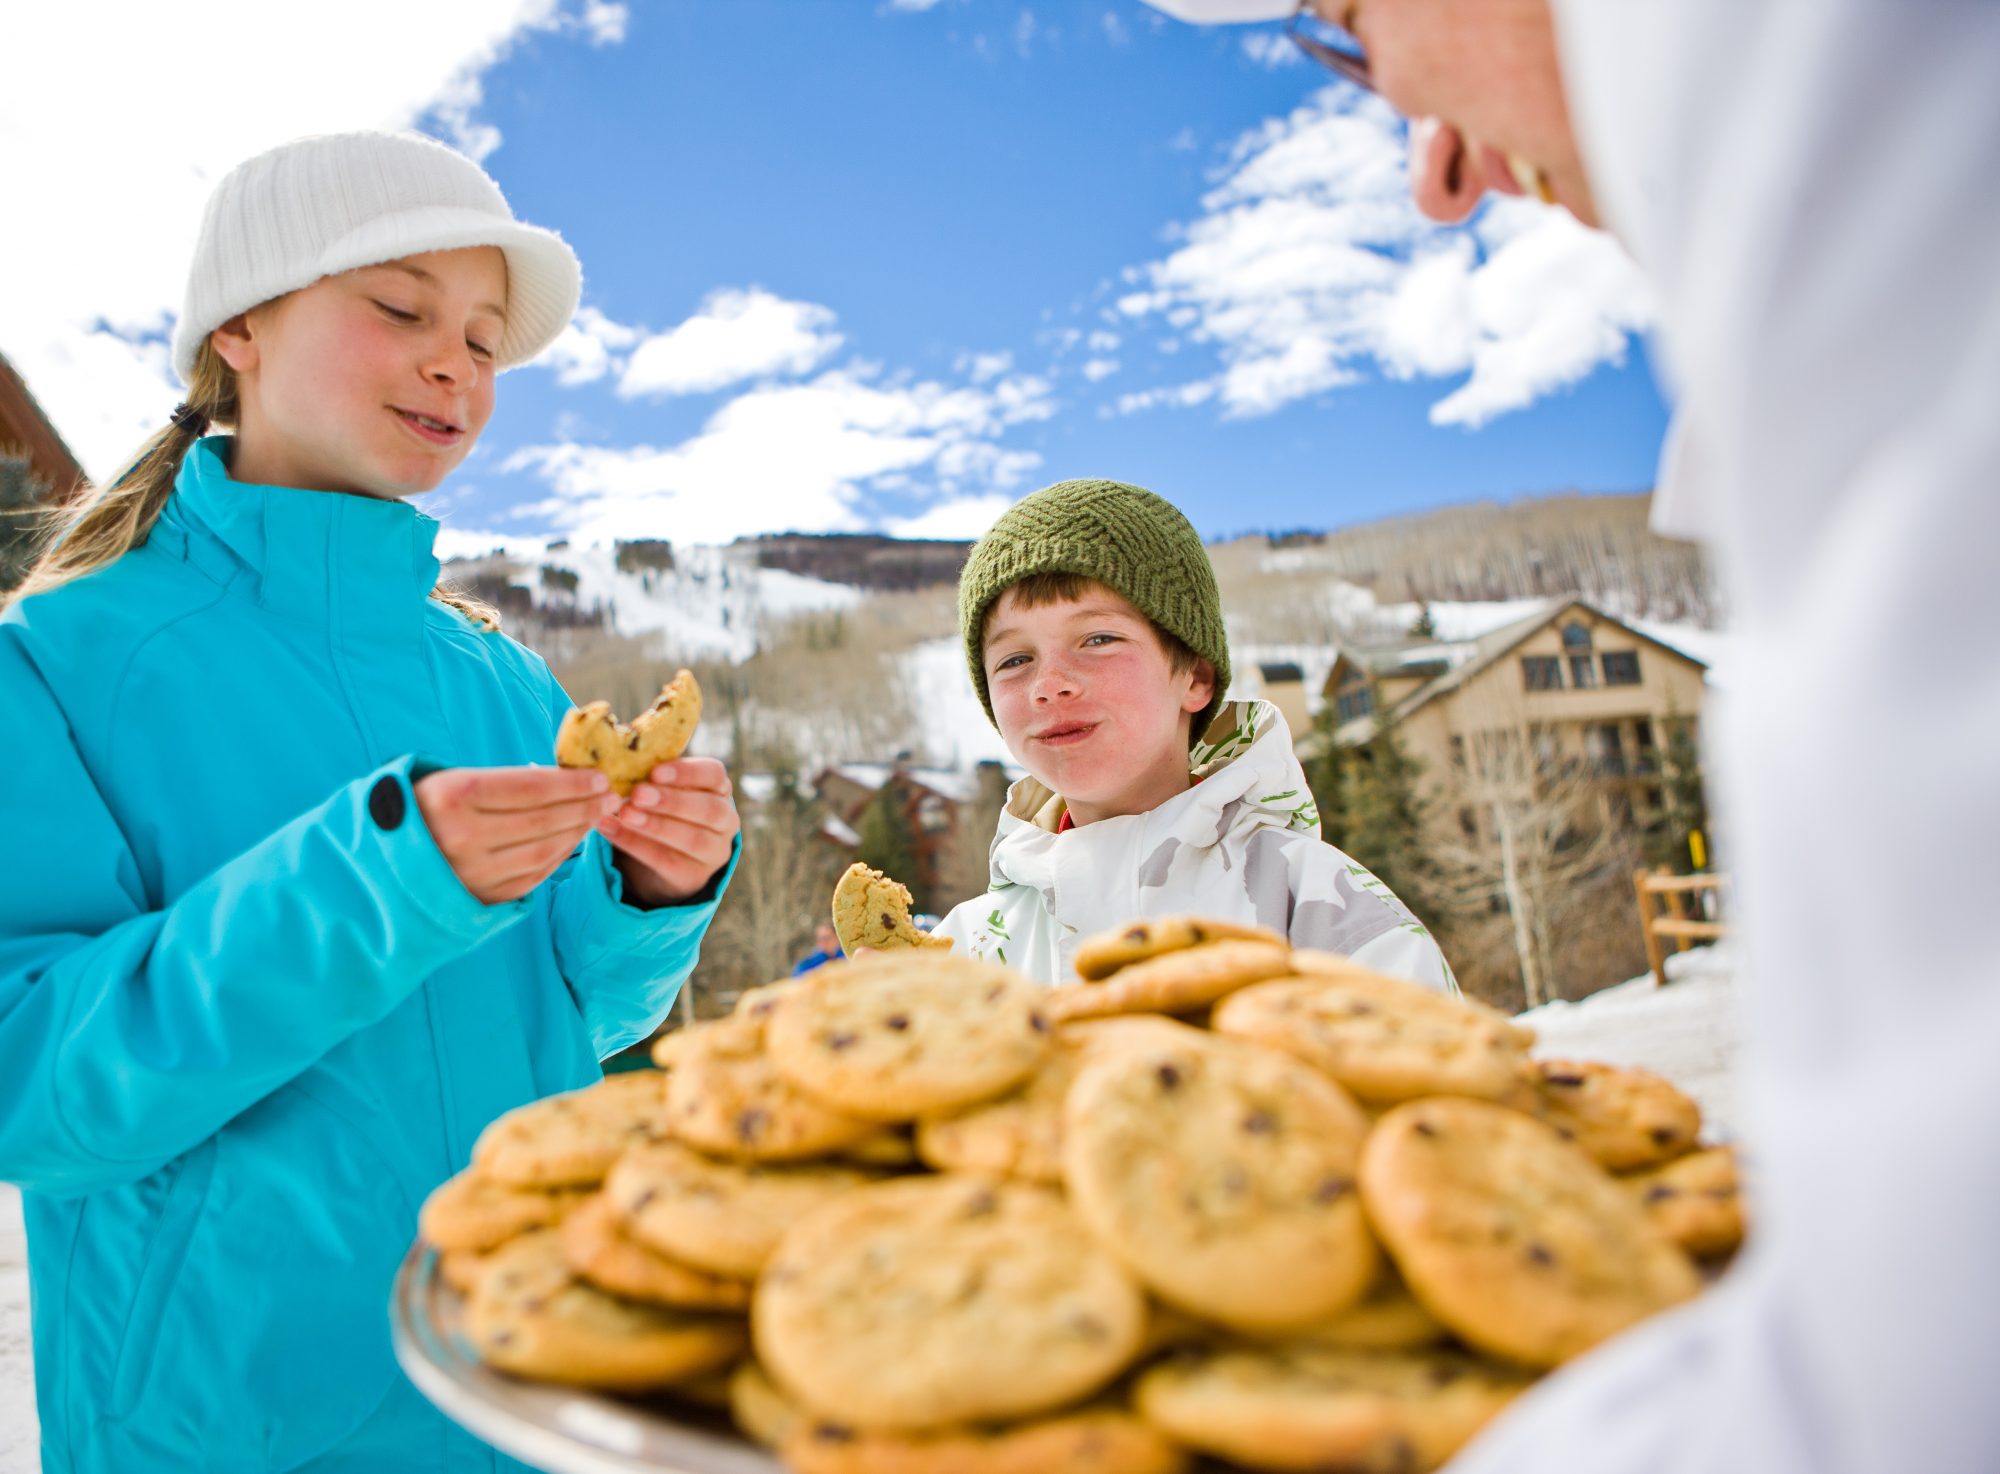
11,0,1666,540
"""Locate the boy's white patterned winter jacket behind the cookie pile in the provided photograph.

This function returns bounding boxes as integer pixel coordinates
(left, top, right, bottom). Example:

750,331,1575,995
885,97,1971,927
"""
936,702,1458,992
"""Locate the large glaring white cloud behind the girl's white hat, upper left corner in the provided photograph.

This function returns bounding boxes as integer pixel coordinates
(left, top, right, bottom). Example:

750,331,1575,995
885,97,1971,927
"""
0,0,616,476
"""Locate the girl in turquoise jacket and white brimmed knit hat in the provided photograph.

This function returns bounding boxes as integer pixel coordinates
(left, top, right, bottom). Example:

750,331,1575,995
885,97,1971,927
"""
0,134,738,1474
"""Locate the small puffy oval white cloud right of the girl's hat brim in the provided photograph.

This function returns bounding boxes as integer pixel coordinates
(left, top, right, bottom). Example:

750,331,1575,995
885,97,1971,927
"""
618,286,844,398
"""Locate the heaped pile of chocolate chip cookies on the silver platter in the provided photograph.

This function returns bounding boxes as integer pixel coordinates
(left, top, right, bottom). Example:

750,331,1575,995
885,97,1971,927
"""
422,918,1742,1474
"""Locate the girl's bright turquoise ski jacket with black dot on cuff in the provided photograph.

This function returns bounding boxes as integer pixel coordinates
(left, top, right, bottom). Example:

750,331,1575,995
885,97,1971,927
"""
0,438,734,1474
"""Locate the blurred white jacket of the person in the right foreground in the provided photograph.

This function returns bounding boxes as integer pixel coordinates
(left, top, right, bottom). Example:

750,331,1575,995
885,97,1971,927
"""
1452,0,2000,1474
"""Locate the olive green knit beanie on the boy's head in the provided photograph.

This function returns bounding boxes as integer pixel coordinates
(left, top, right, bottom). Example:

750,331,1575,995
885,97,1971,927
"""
958,480,1230,746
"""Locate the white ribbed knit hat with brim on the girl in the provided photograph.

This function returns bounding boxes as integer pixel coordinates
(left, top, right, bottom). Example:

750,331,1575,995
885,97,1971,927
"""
174,132,584,382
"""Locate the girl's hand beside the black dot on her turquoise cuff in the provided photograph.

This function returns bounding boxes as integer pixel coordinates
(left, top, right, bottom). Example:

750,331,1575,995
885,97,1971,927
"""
416,768,618,906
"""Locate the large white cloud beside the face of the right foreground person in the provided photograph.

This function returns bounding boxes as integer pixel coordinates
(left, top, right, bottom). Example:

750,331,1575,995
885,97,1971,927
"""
1116,88,1652,426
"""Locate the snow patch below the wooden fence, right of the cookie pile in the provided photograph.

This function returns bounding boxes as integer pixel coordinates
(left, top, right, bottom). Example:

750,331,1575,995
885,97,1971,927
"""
1520,944,1738,1140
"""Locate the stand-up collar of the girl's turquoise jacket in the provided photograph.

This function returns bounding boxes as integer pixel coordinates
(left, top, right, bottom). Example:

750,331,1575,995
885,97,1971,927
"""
164,436,438,626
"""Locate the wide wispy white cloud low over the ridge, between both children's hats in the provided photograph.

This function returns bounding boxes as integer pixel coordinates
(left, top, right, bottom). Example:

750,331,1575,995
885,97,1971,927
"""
506,366,1054,542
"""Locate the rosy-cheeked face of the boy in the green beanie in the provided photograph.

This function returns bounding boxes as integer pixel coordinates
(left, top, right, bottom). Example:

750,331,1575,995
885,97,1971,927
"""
982,586,1212,824
